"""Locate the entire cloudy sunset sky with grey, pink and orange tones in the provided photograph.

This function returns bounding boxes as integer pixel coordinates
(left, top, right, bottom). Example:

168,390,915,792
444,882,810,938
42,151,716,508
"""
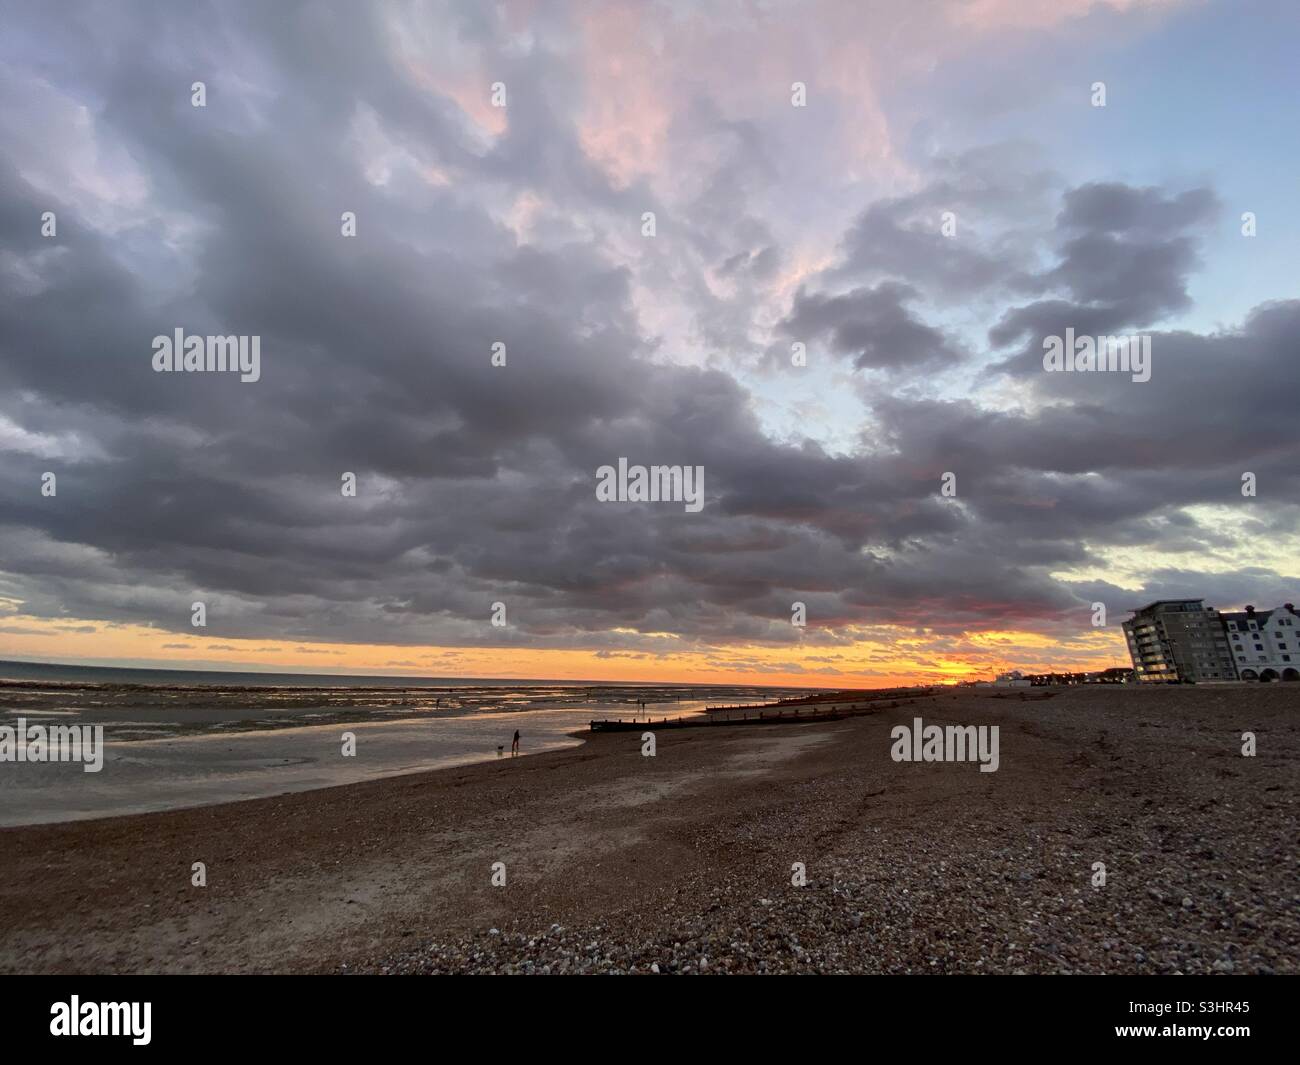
0,0,1300,688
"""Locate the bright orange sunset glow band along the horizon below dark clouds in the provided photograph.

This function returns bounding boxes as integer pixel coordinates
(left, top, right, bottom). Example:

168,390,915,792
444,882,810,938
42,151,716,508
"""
0,615,1128,688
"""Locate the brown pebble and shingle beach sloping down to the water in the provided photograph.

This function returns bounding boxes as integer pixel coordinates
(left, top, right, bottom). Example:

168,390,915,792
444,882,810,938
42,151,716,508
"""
0,685,1300,973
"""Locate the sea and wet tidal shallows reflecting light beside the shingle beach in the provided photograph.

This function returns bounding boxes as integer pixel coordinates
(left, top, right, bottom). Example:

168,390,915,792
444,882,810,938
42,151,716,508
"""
0,662,811,827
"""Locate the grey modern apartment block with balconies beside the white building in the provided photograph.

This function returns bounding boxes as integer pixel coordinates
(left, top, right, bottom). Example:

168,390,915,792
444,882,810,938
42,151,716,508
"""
1123,599,1236,684
